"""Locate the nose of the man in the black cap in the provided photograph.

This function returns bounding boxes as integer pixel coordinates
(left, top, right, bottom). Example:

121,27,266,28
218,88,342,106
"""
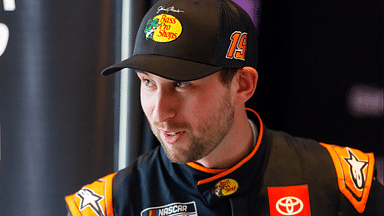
152,89,179,123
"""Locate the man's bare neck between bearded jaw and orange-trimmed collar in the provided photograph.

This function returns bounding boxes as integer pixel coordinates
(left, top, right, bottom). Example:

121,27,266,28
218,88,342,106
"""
196,109,255,169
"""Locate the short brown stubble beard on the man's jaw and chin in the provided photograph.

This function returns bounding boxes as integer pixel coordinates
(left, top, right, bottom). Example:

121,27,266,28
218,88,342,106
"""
151,90,235,164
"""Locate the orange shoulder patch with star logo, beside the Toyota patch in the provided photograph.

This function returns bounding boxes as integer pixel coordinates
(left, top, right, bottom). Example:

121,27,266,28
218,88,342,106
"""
321,143,375,213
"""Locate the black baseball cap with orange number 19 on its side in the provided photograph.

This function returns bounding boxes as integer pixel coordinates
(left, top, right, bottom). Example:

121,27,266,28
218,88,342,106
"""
101,0,258,81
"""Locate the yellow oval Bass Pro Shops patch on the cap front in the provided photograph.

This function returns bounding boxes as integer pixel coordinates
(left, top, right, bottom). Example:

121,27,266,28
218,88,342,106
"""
144,14,183,43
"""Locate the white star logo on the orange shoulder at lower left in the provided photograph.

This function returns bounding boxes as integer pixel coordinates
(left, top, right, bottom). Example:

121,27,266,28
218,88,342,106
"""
77,188,105,216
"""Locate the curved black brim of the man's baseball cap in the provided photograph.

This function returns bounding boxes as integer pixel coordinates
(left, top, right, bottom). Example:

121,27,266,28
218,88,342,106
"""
101,54,222,81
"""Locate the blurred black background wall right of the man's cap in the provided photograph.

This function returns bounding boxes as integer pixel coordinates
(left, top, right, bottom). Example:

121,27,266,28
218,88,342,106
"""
244,0,383,156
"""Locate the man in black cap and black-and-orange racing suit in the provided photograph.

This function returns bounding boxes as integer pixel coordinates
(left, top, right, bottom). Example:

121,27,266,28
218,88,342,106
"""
66,0,383,216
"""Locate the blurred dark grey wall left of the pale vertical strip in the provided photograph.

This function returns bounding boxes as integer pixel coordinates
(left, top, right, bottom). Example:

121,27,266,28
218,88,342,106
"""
0,0,114,216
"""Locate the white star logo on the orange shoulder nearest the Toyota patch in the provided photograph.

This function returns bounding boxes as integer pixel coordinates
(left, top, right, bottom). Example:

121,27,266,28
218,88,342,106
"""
343,149,368,190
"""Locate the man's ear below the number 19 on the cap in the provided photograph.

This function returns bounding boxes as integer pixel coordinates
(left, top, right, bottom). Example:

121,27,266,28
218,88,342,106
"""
232,67,259,104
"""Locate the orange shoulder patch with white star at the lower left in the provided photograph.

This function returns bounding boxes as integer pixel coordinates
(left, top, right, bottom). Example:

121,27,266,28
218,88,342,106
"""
65,173,116,216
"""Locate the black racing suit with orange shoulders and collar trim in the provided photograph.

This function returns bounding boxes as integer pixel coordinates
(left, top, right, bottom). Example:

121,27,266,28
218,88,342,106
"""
66,109,384,216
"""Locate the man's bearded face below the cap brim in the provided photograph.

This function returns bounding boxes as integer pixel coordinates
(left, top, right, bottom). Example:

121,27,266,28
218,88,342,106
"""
137,72,234,163
